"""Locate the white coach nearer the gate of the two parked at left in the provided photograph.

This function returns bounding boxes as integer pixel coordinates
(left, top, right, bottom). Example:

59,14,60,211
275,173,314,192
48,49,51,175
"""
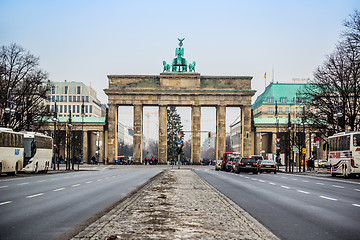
21,132,53,173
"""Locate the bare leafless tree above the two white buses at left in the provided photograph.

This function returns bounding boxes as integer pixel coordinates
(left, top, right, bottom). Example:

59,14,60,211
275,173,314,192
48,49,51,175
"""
0,44,50,131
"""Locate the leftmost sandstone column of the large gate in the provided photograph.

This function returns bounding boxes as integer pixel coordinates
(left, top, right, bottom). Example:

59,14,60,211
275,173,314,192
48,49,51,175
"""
107,104,118,163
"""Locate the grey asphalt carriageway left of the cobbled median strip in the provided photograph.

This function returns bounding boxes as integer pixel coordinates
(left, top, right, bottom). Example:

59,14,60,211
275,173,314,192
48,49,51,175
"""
0,169,161,240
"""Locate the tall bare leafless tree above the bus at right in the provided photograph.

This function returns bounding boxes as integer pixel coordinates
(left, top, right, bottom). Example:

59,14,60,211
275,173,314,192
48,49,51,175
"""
305,11,360,137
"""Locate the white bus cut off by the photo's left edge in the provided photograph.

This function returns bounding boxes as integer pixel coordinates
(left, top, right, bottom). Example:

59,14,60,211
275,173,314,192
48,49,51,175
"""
0,128,24,175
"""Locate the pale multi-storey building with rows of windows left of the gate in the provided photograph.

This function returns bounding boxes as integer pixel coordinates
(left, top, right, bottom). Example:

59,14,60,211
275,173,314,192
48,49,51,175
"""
47,80,106,117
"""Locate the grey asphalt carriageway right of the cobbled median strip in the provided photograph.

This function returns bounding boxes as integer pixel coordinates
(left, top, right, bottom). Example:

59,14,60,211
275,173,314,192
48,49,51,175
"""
196,170,360,240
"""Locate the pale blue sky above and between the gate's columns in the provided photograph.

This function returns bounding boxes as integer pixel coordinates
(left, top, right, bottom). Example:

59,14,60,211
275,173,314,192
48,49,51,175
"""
0,0,360,142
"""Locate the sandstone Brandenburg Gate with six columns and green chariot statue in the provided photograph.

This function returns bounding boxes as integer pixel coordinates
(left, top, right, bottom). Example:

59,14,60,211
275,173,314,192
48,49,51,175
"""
104,39,255,164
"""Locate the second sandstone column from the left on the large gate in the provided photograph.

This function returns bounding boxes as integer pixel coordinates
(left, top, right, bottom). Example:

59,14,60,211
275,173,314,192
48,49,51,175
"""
133,104,143,163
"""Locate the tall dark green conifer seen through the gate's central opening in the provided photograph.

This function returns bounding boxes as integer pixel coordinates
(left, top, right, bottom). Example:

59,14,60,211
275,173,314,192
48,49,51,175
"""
167,107,184,160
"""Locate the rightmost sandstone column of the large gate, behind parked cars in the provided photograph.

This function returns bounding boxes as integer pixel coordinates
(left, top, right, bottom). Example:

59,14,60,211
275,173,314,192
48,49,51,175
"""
241,106,254,157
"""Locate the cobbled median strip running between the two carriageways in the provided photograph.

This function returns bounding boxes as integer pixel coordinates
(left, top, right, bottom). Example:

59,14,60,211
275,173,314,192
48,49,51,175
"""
73,169,278,240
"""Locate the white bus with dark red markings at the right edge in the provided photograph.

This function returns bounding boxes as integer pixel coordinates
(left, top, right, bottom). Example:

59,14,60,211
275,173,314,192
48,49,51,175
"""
329,132,360,178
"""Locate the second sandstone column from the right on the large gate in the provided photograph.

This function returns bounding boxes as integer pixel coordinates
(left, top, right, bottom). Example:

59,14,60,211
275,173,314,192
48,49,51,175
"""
216,106,226,160
